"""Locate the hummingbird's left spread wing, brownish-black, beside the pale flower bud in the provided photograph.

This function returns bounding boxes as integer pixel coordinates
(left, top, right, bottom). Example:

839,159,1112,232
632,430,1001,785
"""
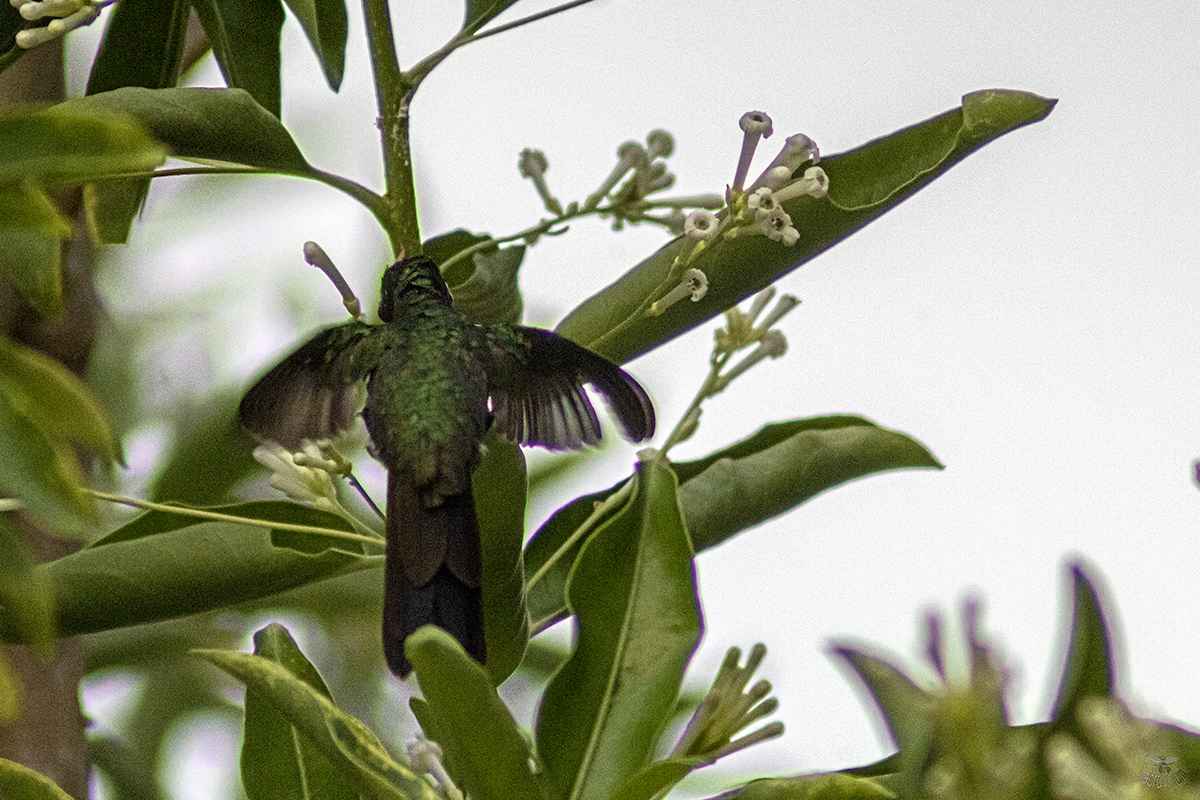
238,323,390,447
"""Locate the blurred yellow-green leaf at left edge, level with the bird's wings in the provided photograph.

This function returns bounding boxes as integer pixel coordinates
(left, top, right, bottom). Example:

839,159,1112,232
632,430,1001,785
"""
0,336,125,464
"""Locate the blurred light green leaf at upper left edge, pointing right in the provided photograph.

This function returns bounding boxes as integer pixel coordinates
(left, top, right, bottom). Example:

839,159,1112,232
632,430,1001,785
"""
0,105,164,186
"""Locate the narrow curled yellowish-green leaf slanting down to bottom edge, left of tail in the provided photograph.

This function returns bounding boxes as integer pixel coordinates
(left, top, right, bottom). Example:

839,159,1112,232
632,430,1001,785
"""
192,650,439,800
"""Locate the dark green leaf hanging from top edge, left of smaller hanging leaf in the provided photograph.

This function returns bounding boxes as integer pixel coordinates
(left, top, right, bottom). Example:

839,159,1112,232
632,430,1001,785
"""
192,0,283,119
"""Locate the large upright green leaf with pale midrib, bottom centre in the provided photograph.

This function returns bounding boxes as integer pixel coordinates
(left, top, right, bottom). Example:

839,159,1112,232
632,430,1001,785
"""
536,463,701,800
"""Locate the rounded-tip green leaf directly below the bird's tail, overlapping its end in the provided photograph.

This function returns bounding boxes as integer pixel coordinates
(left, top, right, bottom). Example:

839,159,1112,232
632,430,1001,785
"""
404,625,544,800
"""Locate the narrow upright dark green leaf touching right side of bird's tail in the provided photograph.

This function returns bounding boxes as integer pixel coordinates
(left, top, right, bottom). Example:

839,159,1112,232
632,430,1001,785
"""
472,431,529,686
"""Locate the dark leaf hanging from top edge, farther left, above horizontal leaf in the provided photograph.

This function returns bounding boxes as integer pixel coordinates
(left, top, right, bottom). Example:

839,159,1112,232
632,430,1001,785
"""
86,0,191,95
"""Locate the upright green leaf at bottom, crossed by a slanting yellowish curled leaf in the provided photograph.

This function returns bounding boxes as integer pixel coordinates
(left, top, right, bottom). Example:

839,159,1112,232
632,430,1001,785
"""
241,624,359,800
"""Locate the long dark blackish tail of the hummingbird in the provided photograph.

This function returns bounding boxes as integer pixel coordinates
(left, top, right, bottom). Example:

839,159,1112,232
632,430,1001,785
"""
383,475,487,678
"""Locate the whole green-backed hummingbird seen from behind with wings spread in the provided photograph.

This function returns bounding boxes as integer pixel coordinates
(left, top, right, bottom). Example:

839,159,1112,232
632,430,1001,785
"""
238,255,654,679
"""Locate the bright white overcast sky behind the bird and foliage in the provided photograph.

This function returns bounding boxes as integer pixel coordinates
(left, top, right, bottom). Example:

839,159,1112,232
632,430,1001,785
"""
68,0,1200,796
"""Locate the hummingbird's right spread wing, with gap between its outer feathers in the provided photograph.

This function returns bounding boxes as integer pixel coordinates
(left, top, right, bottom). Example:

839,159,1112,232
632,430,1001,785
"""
480,325,654,450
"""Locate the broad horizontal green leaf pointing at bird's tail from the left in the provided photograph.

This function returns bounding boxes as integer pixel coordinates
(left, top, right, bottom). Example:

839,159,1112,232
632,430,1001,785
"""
27,523,364,638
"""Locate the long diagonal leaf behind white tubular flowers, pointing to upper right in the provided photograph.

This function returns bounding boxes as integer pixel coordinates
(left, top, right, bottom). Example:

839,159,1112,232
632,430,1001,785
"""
557,90,1056,363
